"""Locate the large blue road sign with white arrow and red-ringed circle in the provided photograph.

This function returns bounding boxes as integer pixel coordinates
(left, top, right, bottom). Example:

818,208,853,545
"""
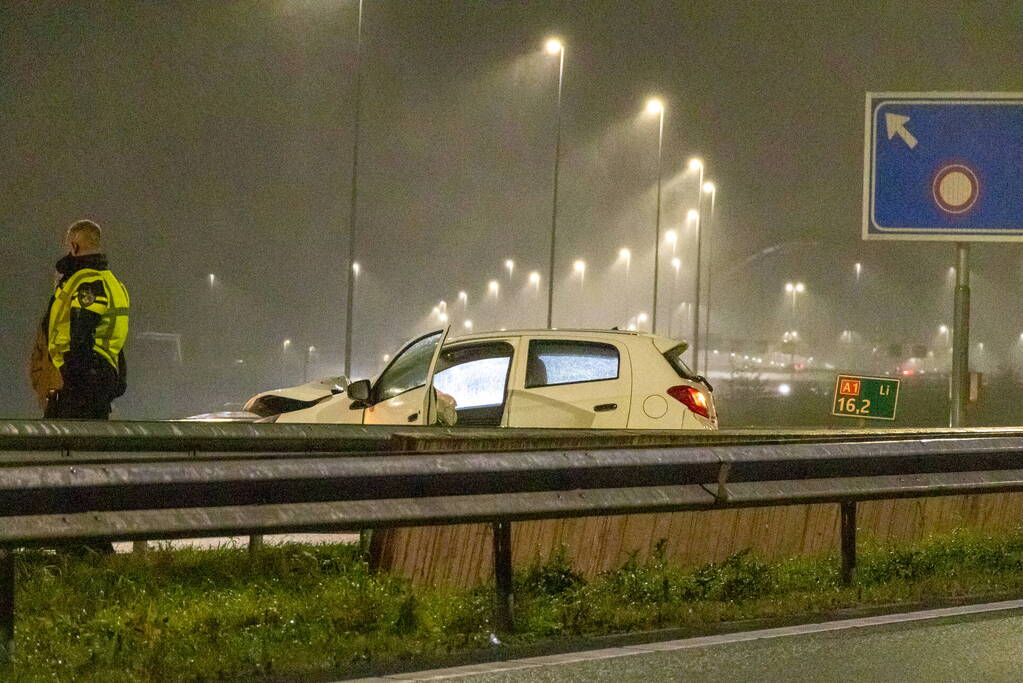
863,92,1023,241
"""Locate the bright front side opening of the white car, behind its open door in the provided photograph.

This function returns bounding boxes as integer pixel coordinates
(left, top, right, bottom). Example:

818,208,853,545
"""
434,342,515,410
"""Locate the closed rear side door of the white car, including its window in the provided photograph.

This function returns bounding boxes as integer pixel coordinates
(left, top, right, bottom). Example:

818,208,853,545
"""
508,337,632,429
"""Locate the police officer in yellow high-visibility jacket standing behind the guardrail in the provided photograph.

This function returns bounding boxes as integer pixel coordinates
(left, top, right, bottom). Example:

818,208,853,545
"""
46,220,130,420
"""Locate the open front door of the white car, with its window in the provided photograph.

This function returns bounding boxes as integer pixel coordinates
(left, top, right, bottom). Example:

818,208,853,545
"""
362,328,448,424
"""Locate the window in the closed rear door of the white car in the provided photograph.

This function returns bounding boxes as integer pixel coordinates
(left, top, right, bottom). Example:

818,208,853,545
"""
526,339,619,389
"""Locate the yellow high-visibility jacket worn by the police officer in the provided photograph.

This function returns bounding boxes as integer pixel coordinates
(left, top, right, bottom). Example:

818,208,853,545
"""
49,268,131,369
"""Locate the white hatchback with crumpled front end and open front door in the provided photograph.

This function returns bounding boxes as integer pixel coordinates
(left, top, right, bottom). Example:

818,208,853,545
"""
244,329,717,429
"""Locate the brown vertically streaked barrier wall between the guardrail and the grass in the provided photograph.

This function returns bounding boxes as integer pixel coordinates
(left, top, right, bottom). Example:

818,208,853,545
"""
372,493,1023,588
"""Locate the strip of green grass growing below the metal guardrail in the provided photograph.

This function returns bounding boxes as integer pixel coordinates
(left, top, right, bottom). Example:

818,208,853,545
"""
7,532,1023,682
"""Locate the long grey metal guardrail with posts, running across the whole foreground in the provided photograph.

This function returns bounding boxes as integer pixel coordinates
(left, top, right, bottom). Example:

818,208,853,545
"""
0,421,1023,651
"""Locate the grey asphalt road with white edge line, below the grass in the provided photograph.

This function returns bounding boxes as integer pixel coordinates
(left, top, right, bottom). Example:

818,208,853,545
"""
362,601,1023,683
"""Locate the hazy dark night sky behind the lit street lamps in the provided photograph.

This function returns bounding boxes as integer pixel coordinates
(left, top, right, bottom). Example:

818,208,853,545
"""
0,0,1023,417
